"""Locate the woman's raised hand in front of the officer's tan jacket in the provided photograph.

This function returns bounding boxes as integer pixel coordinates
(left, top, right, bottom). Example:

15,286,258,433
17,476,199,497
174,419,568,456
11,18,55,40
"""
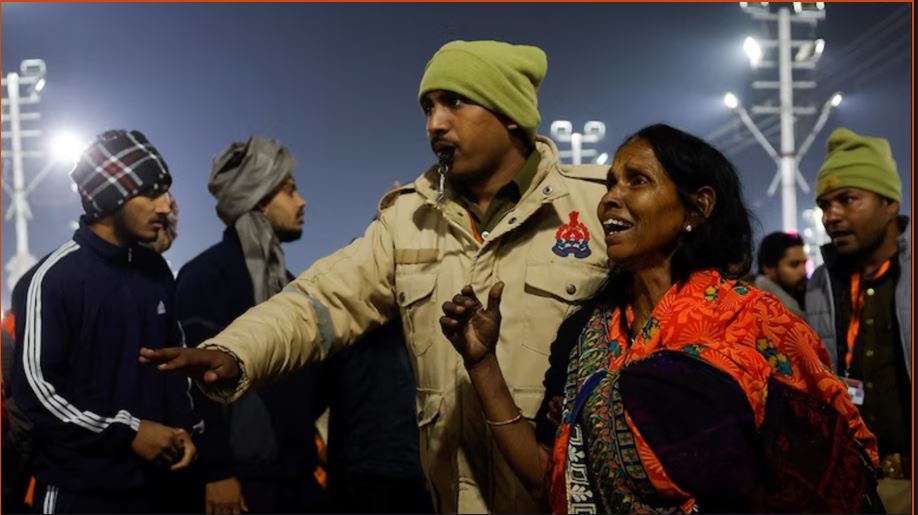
440,282,504,369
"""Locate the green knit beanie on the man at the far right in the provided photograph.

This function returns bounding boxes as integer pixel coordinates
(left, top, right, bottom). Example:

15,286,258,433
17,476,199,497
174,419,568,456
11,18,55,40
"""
816,129,902,202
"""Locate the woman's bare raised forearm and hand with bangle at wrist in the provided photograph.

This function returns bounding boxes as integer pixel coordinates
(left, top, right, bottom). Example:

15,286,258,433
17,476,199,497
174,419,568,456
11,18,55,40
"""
440,283,549,499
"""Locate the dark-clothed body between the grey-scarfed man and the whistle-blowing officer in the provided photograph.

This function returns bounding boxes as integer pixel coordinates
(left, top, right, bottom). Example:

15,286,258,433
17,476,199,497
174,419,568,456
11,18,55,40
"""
322,319,433,513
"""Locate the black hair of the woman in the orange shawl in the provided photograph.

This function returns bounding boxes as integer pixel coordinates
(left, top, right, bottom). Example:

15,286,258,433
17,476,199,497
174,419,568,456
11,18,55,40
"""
619,123,752,282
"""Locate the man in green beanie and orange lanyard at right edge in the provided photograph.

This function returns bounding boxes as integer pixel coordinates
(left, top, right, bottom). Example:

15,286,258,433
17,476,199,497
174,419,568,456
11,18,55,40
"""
806,129,912,513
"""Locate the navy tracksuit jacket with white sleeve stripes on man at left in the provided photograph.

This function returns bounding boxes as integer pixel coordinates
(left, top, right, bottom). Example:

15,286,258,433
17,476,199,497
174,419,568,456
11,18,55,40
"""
12,225,195,491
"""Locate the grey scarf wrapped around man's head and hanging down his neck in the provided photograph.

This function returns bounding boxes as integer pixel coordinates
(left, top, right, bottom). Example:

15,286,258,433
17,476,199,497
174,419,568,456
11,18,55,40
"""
207,136,296,304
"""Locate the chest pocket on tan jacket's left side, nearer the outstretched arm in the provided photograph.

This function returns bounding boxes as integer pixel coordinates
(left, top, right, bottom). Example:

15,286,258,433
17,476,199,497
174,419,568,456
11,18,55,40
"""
395,267,440,356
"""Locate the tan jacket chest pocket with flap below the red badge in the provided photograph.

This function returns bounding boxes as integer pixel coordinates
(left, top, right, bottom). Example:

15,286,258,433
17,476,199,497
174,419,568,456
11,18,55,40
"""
522,260,609,356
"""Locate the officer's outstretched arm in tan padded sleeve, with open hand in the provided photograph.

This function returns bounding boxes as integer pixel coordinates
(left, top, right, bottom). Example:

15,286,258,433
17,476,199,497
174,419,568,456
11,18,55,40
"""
141,205,403,402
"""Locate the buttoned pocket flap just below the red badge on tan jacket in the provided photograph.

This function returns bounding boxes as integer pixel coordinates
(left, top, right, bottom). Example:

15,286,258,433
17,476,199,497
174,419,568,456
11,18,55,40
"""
526,261,609,302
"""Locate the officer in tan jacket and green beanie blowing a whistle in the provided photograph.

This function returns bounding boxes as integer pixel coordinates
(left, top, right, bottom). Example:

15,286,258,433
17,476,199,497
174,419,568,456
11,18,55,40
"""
142,41,608,513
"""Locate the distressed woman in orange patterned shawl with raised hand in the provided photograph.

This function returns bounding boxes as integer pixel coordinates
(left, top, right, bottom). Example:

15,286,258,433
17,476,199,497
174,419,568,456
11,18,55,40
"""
441,125,882,513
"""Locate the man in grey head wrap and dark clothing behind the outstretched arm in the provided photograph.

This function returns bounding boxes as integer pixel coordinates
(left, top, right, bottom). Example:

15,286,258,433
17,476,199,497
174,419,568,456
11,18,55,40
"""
176,136,325,513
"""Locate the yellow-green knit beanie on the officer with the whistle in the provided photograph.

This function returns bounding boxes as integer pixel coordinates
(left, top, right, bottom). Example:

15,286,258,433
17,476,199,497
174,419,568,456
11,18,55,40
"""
418,41,548,140
